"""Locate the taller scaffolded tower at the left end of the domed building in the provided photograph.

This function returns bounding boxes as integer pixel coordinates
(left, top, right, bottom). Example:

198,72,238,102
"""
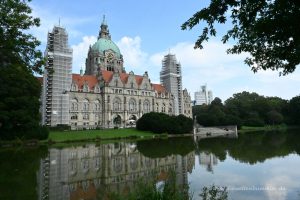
42,26,73,126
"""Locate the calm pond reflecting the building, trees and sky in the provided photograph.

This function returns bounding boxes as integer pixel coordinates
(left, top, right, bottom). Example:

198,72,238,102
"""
0,131,300,200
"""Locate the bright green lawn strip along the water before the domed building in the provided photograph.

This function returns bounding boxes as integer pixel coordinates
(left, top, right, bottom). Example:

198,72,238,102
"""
48,129,155,142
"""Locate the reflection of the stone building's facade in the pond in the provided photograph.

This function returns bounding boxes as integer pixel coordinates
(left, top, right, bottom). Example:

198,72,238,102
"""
38,143,195,200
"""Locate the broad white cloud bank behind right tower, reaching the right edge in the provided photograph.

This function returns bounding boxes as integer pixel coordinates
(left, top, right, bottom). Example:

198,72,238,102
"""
149,40,300,100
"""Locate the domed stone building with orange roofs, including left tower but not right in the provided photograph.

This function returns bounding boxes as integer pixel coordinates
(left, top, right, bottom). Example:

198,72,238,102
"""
41,19,192,129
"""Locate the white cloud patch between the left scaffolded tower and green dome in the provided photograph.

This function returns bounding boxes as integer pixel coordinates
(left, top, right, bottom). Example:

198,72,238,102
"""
72,36,97,73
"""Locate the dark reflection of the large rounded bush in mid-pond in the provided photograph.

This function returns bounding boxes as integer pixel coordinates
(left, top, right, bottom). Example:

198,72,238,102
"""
137,137,195,158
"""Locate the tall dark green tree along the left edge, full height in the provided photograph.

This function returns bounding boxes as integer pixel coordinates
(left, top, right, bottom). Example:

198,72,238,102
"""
0,0,48,139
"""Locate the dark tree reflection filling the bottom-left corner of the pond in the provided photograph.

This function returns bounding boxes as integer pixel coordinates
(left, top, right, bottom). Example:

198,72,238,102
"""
0,146,48,199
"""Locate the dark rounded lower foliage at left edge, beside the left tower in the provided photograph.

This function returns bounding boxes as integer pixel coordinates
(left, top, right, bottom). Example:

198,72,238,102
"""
0,65,48,139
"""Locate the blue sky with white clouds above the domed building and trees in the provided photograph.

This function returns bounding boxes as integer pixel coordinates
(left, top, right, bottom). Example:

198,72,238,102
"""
30,0,300,101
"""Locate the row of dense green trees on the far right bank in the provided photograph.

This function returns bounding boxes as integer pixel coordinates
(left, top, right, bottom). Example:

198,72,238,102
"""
193,91,300,128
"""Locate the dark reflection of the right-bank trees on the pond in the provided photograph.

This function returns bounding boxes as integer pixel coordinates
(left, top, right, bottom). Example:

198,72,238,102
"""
198,131,300,164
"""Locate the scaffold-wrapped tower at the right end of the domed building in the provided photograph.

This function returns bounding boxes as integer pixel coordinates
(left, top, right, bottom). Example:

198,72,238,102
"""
160,54,183,115
